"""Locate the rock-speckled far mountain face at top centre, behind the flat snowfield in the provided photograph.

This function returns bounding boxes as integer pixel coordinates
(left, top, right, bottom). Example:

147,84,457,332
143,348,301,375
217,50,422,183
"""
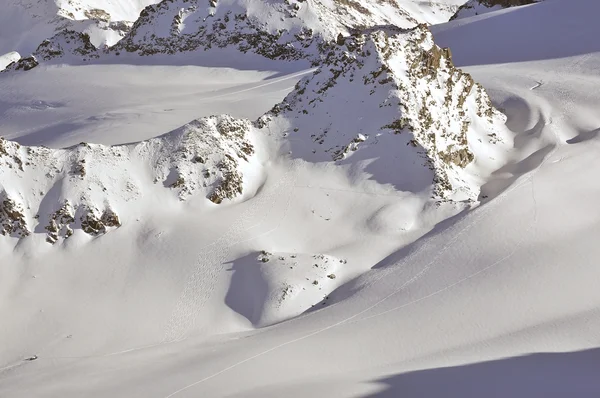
119,0,464,59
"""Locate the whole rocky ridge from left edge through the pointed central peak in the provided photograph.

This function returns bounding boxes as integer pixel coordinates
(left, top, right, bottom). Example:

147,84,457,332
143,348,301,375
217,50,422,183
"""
0,25,510,243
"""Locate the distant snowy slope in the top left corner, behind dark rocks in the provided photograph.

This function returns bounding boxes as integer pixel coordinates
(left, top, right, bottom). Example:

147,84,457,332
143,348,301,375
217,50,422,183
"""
0,0,158,56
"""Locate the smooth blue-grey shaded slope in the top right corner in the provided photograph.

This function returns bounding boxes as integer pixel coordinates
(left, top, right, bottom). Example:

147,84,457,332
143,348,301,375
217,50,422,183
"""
432,0,600,66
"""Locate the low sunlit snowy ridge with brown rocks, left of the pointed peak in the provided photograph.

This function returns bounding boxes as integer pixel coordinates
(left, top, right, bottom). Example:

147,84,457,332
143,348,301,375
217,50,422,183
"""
0,115,260,243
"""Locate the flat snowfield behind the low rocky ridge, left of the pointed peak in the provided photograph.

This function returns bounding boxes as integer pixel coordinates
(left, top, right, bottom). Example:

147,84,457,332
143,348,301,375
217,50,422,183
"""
0,53,310,148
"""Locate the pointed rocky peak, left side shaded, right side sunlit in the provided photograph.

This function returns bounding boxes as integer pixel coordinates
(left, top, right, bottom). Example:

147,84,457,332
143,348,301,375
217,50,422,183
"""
258,25,511,200
